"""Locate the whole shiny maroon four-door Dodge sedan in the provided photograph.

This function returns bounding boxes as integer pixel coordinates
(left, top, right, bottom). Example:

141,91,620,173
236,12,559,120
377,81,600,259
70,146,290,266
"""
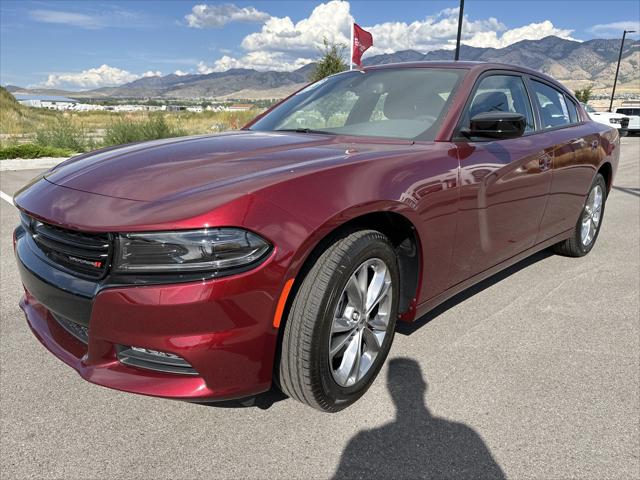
15,62,619,411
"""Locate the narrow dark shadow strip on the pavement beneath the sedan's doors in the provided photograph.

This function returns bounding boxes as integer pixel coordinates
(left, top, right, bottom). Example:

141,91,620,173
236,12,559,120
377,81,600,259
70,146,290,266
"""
396,249,554,335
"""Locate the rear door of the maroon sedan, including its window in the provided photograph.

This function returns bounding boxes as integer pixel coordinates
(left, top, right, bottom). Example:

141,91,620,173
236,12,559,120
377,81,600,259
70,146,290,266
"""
529,78,606,242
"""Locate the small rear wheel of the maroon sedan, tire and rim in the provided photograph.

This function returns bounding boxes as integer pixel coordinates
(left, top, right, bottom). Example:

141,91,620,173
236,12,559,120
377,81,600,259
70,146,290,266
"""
552,173,607,257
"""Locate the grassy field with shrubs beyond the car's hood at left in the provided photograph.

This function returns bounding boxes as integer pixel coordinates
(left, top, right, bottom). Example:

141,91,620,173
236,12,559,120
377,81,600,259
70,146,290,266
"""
0,87,260,158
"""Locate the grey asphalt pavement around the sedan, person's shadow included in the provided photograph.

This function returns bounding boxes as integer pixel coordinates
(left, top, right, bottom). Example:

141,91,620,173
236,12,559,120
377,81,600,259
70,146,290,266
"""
0,138,640,479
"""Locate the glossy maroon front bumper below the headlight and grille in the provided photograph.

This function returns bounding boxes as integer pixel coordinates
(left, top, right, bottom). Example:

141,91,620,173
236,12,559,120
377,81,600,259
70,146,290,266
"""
16,232,278,401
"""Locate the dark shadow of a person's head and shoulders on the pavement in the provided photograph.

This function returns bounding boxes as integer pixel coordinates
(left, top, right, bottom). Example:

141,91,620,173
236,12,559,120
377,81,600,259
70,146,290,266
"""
333,358,505,480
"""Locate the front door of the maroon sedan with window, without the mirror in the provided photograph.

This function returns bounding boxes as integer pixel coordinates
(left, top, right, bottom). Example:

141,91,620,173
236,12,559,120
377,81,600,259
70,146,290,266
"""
450,72,554,285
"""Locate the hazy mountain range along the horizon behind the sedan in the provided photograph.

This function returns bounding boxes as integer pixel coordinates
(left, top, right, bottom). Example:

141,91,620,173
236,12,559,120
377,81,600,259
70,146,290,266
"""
7,36,640,99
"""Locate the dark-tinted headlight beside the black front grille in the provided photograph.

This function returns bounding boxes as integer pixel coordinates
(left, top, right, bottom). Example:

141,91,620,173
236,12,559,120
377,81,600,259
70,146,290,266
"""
113,228,271,273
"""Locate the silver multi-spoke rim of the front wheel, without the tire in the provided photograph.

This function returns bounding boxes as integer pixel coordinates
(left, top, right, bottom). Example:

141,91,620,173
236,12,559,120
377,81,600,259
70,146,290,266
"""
329,258,392,387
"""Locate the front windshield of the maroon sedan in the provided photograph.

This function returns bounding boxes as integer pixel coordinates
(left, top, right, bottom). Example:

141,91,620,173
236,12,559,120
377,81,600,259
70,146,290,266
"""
250,68,465,140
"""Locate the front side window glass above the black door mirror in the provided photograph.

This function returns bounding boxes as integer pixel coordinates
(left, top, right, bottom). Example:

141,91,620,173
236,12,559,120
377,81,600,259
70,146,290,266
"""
464,75,535,132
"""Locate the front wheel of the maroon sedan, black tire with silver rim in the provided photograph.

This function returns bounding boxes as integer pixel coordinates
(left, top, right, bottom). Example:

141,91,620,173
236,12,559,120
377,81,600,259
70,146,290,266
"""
277,230,399,412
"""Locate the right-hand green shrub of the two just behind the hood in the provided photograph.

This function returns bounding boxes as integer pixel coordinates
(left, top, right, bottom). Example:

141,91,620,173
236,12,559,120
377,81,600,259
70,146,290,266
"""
104,114,187,145
